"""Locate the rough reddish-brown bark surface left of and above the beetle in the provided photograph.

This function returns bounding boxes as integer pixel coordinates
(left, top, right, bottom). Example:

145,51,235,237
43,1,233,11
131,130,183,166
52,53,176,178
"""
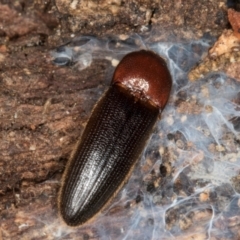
0,0,233,239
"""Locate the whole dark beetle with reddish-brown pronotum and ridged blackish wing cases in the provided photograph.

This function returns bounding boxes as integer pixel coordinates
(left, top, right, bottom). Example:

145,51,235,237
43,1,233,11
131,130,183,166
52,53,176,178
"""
59,50,172,226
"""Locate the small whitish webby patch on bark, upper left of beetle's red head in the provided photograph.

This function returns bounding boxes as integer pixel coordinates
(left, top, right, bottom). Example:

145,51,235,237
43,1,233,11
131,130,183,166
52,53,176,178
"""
51,34,146,68
